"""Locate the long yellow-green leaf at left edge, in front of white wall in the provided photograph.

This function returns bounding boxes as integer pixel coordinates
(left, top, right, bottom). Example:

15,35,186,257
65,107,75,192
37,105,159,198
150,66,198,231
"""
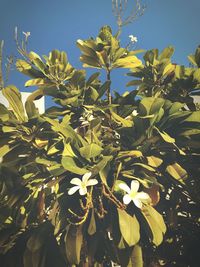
2,85,26,122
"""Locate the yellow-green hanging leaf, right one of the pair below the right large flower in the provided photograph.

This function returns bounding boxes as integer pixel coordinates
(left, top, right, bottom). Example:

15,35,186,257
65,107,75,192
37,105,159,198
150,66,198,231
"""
142,206,166,246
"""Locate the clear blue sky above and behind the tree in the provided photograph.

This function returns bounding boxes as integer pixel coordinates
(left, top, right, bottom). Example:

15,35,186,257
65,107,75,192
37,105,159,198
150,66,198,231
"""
0,0,200,107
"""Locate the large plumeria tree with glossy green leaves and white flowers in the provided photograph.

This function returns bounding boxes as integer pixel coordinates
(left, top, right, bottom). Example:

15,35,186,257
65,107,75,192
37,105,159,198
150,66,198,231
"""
0,26,200,267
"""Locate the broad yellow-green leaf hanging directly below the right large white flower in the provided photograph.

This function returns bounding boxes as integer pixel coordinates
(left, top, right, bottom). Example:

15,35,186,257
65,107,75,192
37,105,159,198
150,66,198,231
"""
117,209,140,247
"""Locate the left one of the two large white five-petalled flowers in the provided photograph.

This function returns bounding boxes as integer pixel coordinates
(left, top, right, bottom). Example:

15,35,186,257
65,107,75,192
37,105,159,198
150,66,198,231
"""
68,172,98,196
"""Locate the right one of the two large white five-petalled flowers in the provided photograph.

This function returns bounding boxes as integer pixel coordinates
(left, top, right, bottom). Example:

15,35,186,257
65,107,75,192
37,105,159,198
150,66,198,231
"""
119,180,150,209
